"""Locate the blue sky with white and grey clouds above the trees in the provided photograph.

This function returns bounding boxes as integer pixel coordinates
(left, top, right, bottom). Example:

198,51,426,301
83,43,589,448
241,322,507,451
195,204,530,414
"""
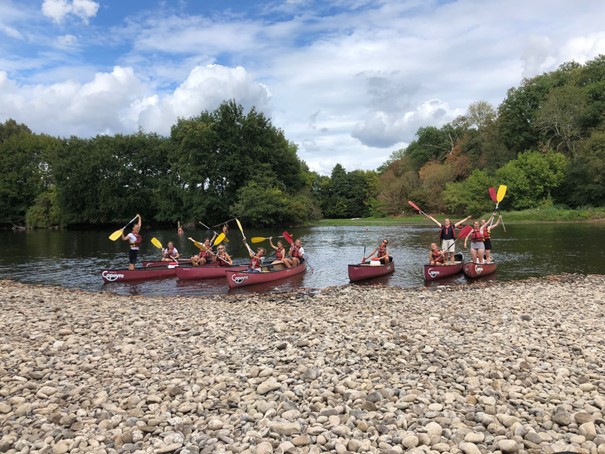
0,0,605,175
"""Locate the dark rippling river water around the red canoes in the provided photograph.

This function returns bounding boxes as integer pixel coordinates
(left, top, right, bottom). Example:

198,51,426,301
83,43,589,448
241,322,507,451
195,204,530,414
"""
0,223,605,295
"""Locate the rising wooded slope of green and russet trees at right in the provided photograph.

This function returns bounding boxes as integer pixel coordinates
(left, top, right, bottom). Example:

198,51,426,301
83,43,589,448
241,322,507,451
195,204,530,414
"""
377,56,605,214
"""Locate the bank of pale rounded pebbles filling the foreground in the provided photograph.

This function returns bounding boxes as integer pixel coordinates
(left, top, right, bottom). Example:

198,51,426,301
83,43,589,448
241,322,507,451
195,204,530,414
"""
0,275,605,454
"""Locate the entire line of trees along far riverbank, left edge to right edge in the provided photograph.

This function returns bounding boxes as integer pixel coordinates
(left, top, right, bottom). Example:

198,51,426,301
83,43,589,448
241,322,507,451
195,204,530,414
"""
0,56,605,227
